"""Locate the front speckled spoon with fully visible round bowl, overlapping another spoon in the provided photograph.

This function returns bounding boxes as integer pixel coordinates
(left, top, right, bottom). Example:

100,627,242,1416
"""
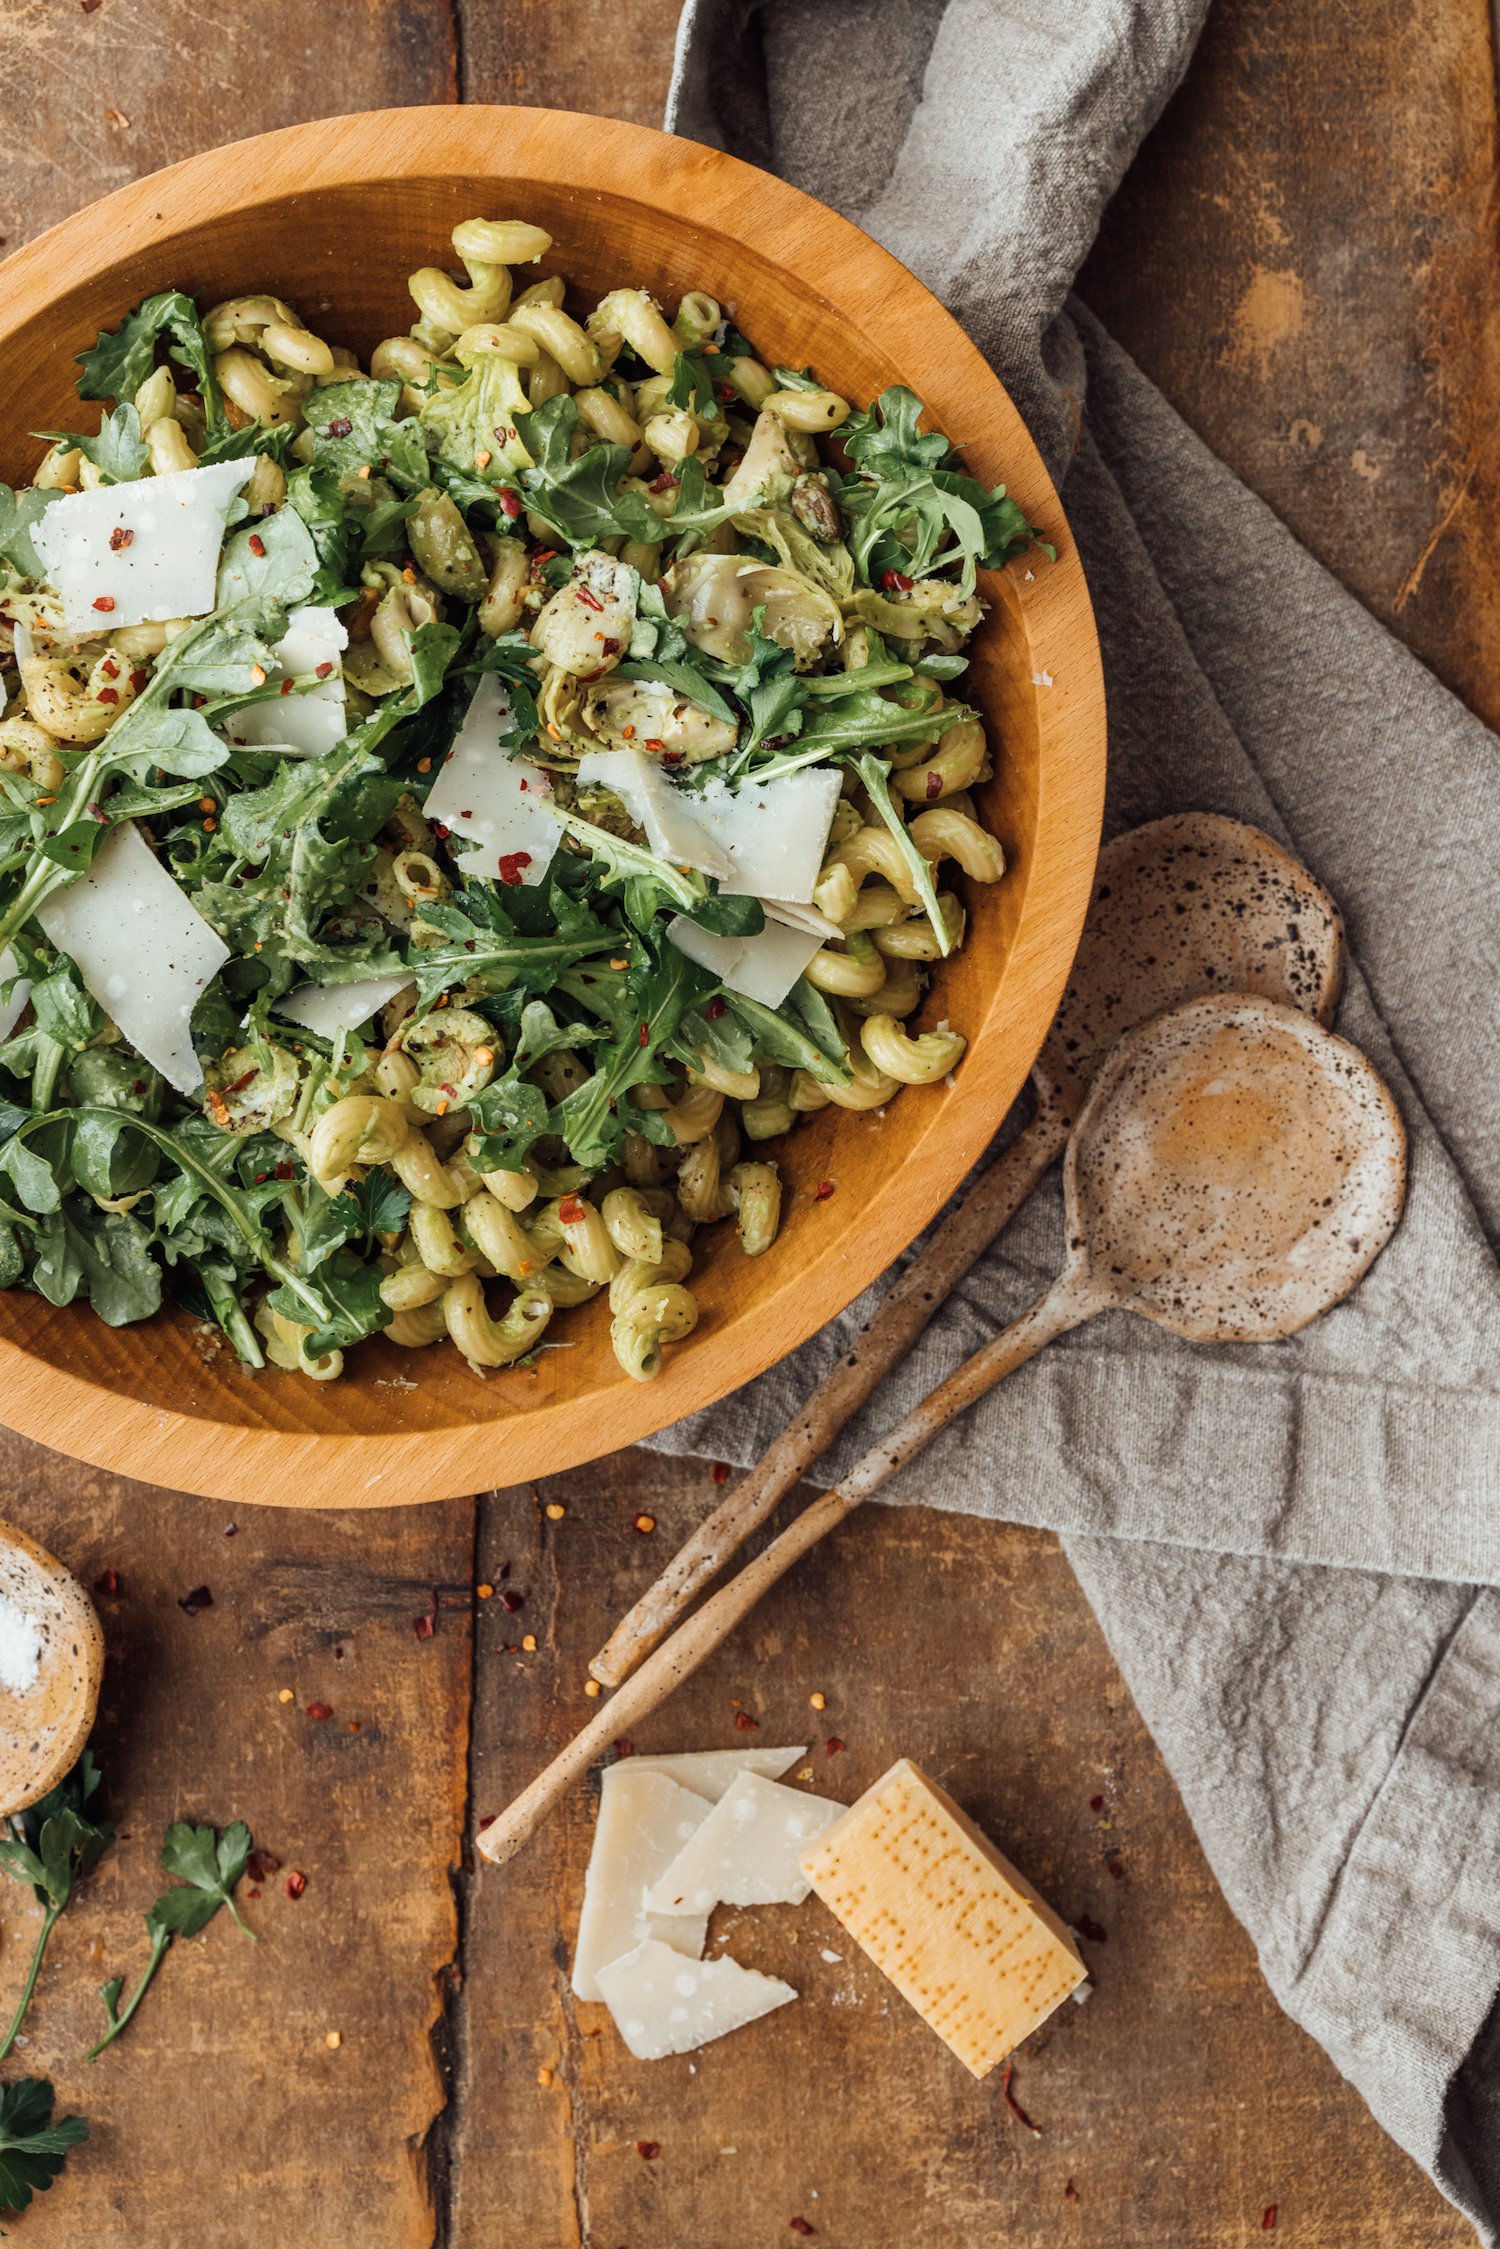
490,994,1406,1860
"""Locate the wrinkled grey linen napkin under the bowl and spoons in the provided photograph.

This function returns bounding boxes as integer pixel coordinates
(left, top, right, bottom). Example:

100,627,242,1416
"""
657,0,1500,2249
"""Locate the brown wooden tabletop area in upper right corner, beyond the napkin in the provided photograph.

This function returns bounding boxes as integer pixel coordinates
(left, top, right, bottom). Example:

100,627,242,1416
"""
1082,0,1500,724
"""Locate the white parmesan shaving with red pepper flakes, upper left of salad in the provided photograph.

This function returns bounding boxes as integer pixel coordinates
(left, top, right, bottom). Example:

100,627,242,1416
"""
31,461,254,636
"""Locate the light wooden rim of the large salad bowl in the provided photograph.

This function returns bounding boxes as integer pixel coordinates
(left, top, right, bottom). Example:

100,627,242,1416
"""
0,106,1104,1507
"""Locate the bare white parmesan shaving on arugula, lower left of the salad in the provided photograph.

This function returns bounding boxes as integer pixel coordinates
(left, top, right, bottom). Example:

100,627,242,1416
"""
36,823,229,1093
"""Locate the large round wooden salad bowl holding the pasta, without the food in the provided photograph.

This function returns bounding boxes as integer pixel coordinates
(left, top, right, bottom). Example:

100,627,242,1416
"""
0,108,1104,1507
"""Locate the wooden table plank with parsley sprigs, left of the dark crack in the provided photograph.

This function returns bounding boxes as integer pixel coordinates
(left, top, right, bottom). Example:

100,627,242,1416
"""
0,1437,472,2249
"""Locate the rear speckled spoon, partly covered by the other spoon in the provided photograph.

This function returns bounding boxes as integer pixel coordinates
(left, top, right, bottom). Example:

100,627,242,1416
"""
589,812,1343,1687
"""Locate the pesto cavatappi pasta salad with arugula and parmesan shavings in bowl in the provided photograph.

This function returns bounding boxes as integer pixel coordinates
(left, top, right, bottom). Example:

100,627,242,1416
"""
0,218,1034,1381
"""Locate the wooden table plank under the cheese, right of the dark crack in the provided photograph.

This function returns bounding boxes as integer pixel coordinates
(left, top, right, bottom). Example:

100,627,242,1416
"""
443,1455,1469,2249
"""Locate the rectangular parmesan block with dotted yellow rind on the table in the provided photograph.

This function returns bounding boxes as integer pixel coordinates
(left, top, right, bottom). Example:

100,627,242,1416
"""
803,1759,1086,2078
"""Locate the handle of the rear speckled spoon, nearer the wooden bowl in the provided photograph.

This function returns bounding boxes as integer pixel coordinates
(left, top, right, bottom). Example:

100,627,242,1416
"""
589,1104,1068,1687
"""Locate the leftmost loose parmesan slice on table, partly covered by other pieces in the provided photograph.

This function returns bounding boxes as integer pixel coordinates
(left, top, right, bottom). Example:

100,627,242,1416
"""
573,1759,711,1999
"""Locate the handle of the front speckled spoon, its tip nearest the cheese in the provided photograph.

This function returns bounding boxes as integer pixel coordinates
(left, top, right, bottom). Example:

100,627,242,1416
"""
479,1271,1102,1862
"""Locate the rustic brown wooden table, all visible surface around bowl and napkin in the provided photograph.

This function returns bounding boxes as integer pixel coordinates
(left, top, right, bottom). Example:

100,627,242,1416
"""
0,0,1500,2249
